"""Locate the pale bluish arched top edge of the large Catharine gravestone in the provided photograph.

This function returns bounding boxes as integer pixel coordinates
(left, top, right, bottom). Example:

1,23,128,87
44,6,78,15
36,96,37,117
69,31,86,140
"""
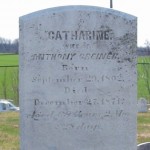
20,5,136,20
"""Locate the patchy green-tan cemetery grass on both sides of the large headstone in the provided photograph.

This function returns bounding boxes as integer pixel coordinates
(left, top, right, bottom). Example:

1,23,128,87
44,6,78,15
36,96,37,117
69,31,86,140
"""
0,112,150,150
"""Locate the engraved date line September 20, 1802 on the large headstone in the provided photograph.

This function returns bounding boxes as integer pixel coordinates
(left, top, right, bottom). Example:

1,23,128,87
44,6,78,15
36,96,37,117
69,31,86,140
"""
31,74,124,84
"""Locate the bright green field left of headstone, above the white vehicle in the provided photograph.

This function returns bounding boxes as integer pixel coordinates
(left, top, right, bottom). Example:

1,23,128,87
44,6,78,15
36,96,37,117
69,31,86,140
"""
0,54,19,105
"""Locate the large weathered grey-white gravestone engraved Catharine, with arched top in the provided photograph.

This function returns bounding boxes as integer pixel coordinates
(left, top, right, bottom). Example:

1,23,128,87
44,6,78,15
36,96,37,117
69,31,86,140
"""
19,6,137,150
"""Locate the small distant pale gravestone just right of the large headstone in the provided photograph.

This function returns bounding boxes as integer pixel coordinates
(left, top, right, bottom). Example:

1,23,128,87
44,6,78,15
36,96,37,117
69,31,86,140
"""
138,98,148,113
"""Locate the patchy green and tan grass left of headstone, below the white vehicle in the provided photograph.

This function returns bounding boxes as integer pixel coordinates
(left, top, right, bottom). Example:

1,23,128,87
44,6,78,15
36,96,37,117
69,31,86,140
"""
0,112,19,150
